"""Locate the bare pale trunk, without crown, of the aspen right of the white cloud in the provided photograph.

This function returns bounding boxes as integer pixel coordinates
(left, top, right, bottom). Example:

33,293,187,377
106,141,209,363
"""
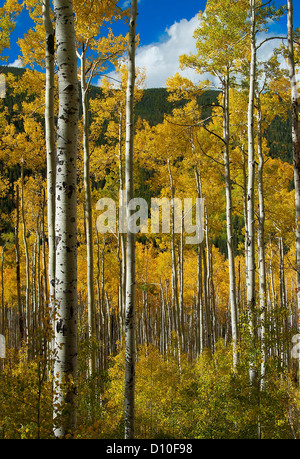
223,72,238,369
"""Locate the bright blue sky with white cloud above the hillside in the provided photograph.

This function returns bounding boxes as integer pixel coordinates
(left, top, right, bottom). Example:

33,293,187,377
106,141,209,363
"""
0,0,300,87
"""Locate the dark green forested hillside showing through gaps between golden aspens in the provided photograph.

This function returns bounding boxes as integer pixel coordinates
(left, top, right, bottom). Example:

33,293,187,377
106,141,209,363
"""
0,67,292,257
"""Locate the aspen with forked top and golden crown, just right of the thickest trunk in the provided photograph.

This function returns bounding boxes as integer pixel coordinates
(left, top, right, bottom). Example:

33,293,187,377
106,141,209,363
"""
74,0,125,374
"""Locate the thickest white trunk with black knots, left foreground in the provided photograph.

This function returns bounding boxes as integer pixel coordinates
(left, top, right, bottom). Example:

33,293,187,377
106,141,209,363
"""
54,0,79,438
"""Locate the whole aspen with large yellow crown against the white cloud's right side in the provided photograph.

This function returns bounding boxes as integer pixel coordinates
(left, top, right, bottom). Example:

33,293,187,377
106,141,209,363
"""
180,0,247,368
